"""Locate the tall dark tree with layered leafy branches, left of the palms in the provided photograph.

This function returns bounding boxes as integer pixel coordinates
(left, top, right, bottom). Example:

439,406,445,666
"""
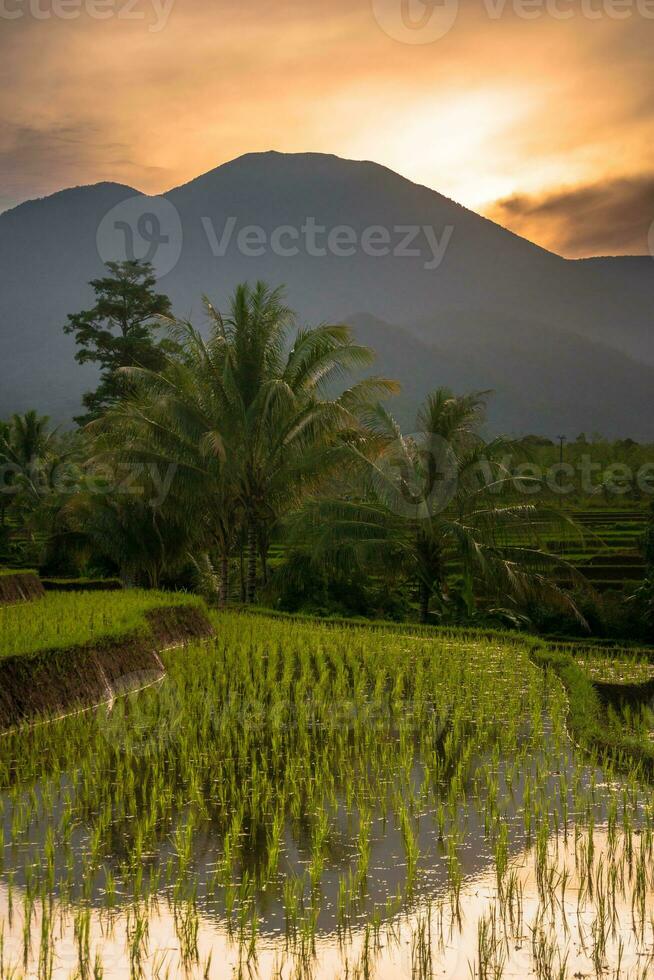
64,260,174,425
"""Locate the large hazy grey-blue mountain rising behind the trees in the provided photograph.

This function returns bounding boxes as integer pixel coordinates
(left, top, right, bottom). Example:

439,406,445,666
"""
0,153,654,439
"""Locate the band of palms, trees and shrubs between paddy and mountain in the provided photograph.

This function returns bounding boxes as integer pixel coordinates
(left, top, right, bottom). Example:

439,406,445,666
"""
0,263,654,639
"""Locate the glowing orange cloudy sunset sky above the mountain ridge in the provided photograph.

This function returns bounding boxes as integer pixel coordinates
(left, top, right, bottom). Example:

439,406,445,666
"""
0,0,654,257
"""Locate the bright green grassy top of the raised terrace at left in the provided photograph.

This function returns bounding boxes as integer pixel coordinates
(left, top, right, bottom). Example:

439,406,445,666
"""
0,589,200,658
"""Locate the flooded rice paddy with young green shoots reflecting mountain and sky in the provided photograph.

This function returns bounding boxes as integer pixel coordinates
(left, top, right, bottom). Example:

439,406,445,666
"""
0,594,654,980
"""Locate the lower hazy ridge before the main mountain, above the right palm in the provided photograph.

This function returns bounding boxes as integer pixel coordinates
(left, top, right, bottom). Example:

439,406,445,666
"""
350,313,654,441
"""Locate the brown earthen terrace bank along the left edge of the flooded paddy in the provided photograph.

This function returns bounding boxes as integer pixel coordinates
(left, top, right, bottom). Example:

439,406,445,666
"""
0,606,214,731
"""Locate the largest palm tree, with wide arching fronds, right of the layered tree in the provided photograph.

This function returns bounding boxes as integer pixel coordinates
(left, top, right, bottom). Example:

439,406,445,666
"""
96,282,397,603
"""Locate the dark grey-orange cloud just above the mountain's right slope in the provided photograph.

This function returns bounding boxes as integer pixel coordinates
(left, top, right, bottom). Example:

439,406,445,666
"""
485,173,654,258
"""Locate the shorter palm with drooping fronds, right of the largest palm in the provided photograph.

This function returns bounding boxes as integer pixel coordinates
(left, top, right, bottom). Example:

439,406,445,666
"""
292,388,577,622
